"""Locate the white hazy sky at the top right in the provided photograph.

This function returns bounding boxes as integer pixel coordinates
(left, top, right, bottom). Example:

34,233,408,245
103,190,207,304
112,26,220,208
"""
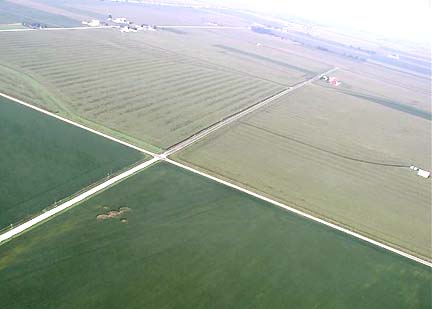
217,0,432,41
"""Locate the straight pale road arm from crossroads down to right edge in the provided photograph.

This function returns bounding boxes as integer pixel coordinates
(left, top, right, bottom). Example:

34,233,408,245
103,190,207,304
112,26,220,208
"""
164,158,432,267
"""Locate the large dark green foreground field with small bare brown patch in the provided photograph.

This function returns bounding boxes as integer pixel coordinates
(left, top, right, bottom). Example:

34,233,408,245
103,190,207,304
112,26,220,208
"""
0,163,432,308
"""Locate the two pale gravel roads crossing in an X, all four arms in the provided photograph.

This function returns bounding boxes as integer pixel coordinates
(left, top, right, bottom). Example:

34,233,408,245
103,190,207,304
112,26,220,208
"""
0,59,432,267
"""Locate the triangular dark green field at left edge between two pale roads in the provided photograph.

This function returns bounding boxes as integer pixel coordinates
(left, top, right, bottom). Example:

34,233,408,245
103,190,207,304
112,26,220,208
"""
0,97,144,229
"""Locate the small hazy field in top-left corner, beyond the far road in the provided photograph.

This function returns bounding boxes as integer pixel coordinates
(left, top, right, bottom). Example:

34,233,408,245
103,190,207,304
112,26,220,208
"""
0,0,81,27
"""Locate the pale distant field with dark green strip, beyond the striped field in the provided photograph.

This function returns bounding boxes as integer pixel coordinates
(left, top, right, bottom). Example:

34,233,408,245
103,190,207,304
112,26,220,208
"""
137,28,332,85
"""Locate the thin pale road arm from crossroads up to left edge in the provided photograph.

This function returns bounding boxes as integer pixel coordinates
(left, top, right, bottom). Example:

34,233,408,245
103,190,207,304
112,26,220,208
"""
0,92,158,157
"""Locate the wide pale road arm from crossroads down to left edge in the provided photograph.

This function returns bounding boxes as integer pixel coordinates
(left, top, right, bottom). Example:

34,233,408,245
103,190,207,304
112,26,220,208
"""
0,158,160,244
